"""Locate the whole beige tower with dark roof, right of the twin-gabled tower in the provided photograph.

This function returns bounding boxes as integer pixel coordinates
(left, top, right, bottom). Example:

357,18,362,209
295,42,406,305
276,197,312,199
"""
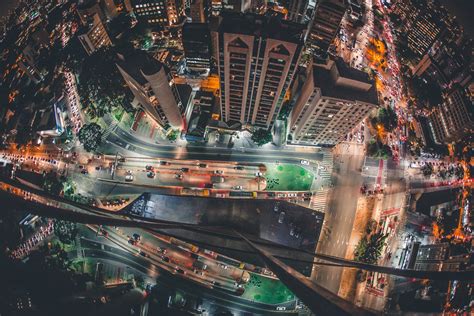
291,59,378,146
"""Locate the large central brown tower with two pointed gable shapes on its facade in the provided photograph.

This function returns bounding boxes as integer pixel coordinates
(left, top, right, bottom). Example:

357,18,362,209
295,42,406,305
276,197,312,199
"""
213,13,304,128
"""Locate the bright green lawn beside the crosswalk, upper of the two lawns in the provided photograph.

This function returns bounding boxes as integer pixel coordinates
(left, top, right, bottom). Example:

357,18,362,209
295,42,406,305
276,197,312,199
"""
265,164,314,191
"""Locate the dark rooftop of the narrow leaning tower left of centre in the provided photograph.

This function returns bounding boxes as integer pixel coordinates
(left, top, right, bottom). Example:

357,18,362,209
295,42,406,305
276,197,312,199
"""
117,50,163,85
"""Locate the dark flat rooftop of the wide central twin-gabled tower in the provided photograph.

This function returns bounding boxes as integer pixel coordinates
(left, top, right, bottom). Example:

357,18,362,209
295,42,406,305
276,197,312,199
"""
218,12,306,43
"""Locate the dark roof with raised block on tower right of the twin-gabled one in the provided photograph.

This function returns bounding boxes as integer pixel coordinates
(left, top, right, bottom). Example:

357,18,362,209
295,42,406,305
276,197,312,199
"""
313,60,379,105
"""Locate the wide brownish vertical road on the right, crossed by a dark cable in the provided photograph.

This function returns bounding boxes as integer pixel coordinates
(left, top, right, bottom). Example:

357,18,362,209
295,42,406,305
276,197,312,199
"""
311,143,364,294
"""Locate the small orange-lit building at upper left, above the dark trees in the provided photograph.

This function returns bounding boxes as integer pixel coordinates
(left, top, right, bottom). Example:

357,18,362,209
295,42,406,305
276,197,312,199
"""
78,13,112,55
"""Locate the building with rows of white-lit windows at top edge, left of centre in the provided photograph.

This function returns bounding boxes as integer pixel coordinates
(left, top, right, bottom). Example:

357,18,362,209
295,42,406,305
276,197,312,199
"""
132,0,170,26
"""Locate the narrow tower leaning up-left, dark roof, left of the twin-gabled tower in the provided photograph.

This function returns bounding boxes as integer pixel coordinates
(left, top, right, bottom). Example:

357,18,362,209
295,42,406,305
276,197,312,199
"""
117,51,184,129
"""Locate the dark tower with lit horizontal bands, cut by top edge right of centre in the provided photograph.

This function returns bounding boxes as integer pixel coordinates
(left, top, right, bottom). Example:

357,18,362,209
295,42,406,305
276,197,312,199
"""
307,0,346,56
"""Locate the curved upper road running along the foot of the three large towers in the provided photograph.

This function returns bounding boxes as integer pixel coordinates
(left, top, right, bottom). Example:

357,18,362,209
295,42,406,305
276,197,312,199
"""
102,127,324,163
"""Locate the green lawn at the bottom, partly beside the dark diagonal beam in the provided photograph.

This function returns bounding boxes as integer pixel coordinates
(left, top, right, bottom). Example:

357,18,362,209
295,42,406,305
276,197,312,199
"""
242,273,295,305
